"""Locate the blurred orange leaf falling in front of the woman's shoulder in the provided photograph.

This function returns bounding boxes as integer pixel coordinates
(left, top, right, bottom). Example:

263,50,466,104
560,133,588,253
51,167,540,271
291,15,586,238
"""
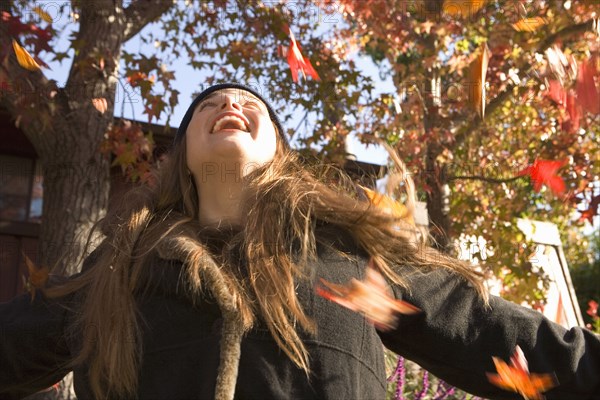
316,259,421,330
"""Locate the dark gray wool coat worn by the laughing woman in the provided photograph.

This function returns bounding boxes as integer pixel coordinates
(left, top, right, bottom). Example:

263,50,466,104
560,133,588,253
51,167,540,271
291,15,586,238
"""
0,230,600,400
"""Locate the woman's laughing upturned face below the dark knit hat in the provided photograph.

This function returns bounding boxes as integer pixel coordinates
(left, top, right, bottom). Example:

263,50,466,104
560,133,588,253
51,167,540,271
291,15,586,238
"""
186,89,277,177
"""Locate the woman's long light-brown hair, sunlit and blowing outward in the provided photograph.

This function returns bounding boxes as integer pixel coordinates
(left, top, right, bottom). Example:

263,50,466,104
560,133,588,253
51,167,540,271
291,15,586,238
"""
46,126,487,398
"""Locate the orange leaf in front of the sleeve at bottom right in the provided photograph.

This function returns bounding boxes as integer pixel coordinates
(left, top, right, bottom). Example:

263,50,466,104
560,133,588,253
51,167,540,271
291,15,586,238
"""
486,346,558,400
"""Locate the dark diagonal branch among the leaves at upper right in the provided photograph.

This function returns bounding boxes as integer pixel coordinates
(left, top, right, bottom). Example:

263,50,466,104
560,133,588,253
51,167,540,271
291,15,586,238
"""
455,19,594,144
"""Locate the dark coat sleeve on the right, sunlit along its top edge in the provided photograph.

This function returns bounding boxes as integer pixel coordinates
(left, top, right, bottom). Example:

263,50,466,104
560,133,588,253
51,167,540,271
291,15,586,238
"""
379,270,600,400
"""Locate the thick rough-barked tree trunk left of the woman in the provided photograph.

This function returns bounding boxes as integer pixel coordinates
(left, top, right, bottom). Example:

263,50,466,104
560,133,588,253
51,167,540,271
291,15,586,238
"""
38,0,126,274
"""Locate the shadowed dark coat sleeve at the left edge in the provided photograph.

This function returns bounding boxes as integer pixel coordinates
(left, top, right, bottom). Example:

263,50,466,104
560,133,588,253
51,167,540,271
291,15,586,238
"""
0,293,70,400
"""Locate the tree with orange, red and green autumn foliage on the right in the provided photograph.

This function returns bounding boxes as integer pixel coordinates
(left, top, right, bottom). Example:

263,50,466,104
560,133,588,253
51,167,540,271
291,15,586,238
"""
304,0,600,303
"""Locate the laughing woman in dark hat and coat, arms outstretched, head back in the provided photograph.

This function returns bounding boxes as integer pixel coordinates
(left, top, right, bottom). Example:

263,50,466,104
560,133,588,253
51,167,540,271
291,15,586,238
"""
0,84,600,399
